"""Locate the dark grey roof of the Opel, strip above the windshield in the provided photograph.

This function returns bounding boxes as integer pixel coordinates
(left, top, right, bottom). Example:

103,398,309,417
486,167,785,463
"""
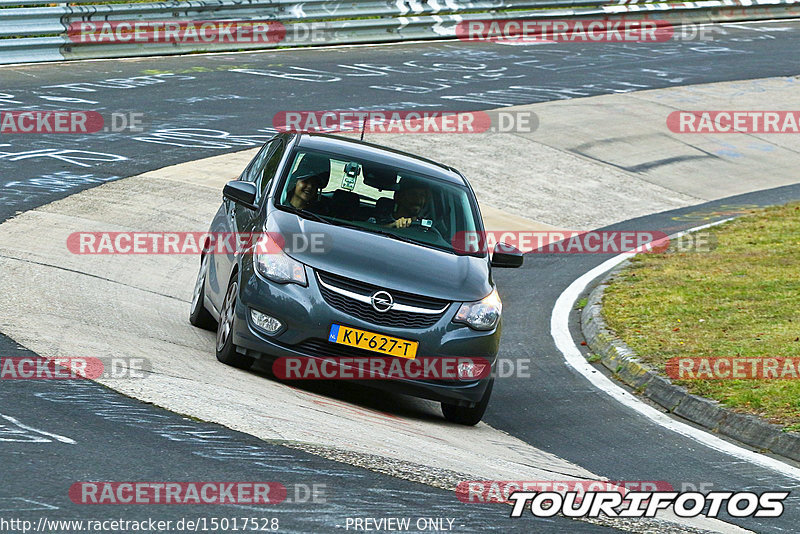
298,133,464,185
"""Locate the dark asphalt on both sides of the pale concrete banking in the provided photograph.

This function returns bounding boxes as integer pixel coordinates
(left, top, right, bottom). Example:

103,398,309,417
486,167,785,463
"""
0,22,800,532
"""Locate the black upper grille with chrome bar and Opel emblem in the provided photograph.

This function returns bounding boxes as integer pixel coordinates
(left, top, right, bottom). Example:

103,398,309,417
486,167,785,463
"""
317,271,449,328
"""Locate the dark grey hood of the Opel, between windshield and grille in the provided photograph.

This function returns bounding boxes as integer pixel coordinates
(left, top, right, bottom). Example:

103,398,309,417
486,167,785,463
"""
267,209,492,302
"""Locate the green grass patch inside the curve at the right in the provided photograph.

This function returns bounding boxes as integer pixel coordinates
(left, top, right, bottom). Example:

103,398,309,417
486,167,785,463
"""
603,203,800,431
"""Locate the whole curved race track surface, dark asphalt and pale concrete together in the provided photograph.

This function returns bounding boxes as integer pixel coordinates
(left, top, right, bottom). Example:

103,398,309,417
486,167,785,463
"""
0,21,800,532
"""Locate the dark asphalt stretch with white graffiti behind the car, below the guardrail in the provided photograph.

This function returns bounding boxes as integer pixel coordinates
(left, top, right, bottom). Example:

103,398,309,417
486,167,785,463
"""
0,21,800,220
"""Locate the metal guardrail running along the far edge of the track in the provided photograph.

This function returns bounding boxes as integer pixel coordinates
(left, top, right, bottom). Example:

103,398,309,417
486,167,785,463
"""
0,0,800,64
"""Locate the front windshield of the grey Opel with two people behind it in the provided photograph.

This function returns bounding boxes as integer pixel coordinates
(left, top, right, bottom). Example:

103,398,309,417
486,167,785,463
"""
276,150,481,255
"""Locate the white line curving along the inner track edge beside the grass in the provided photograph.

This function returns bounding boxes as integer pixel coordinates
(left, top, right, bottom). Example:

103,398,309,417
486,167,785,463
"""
550,219,800,480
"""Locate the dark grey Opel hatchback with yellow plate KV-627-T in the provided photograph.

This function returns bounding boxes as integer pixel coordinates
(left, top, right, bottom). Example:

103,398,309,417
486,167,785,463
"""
190,134,522,425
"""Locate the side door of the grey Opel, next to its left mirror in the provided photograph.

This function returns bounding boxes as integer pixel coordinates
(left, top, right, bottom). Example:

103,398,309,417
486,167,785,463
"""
206,138,283,310
